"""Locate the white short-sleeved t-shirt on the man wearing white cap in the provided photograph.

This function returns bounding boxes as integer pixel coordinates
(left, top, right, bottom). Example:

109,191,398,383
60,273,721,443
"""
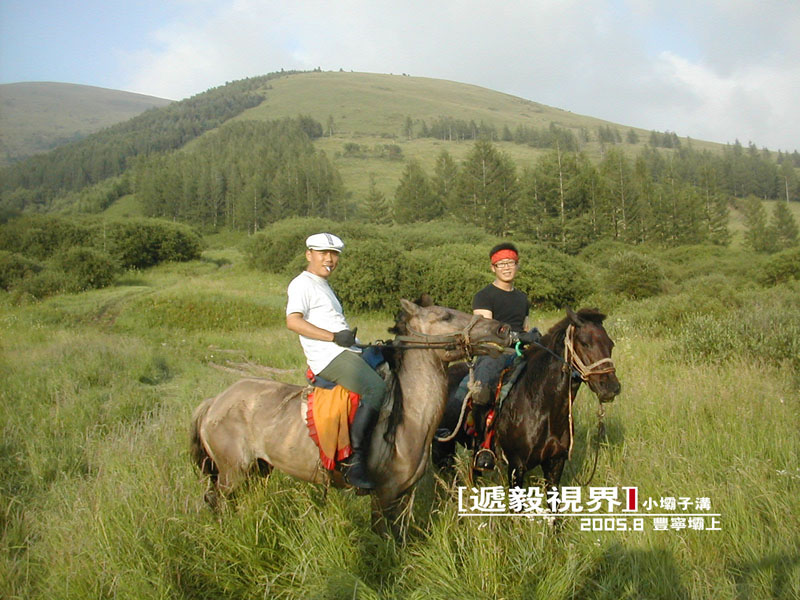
286,271,360,375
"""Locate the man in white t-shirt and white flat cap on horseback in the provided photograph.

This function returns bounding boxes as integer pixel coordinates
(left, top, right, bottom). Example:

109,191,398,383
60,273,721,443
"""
286,233,386,489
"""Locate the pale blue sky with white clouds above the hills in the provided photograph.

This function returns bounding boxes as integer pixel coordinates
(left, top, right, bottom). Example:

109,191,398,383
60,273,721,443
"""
0,0,800,151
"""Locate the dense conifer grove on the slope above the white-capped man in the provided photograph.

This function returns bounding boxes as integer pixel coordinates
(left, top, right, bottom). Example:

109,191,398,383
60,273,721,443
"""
133,116,350,233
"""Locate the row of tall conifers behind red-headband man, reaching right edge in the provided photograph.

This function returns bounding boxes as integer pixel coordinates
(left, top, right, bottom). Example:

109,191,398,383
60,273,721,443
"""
384,140,798,253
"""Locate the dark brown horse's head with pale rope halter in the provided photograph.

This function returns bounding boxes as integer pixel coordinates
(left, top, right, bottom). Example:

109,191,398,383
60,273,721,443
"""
564,308,621,402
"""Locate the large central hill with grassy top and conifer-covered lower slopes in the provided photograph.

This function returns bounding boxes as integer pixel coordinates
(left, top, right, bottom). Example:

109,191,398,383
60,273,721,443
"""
0,71,800,251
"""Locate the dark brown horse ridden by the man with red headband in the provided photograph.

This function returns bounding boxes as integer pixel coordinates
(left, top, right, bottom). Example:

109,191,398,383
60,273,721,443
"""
434,309,620,488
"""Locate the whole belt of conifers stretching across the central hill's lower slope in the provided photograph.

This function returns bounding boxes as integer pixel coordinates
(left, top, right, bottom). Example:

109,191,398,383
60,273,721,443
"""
95,116,798,253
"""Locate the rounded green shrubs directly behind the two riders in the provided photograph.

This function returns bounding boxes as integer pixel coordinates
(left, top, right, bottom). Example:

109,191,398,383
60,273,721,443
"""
253,219,594,311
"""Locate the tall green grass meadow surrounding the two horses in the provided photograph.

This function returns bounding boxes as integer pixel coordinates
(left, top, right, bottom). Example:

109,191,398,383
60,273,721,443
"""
0,235,800,600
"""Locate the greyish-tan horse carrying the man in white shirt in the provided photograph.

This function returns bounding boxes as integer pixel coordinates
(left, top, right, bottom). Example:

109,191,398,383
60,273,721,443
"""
192,300,510,526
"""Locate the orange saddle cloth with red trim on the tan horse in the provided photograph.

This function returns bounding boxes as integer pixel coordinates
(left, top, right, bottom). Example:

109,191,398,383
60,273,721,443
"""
306,385,361,471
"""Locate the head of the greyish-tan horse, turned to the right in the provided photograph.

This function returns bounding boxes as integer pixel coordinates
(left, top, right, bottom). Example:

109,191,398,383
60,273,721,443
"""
393,299,511,362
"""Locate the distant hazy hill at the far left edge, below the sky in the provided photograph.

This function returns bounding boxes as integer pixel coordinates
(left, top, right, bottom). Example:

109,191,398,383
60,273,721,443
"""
0,82,171,166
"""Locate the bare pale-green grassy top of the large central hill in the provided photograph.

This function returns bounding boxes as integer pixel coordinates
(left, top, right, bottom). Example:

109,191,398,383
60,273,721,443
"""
230,72,722,198
